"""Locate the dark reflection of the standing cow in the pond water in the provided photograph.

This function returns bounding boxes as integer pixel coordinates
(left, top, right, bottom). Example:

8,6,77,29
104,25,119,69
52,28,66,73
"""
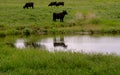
53,37,67,48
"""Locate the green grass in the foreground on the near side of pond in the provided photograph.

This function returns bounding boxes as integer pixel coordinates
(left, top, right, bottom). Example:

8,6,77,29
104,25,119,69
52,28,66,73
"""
0,46,120,75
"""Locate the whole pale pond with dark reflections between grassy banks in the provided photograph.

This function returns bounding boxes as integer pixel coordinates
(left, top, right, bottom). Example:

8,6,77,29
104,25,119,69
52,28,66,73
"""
2,35,120,55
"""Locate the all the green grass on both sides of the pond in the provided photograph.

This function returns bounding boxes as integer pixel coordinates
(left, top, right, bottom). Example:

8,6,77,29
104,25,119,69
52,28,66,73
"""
0,0,120,75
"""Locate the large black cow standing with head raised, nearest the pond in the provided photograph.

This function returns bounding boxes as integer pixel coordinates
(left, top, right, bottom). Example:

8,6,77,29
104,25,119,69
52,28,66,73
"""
53,10,67,22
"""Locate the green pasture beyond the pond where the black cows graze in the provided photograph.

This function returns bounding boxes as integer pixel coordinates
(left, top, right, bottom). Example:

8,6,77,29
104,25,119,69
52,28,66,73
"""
0,0,120,35
